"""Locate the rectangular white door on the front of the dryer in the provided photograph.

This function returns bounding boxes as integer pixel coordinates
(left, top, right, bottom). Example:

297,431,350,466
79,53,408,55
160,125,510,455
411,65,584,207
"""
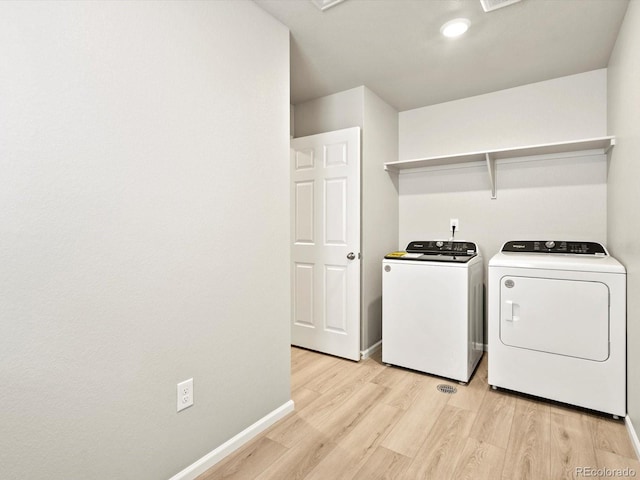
500,276,609,361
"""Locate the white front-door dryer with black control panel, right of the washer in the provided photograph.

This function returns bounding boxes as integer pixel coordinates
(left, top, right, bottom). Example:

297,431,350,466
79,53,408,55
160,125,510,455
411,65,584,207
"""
487,241,626,416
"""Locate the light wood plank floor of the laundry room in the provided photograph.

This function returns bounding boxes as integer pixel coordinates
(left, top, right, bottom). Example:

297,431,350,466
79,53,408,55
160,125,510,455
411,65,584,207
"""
198,348,640,480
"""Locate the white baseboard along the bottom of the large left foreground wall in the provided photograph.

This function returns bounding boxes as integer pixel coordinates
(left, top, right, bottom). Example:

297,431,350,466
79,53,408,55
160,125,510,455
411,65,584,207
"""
169,400,294,480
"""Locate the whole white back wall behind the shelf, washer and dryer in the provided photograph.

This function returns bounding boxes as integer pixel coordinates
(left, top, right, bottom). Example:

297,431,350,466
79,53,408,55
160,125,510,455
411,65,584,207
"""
398,70,607,344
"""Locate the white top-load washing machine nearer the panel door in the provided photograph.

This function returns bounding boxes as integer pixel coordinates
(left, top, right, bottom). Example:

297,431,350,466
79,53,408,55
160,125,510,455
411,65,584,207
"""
382,240,484,383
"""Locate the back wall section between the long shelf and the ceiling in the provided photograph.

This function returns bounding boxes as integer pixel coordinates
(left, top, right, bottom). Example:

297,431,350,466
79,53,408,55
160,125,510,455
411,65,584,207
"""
399,69,607,160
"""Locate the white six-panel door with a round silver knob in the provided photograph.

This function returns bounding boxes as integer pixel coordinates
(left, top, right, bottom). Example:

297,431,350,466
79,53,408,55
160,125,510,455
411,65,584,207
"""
291,127,360,360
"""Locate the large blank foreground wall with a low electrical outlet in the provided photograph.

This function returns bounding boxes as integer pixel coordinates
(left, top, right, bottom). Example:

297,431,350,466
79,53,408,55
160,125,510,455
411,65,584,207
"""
0,1,290,480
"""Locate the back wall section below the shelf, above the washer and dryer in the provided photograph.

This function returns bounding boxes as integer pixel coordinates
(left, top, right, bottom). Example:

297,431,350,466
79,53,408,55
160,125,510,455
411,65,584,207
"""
399,155,607,258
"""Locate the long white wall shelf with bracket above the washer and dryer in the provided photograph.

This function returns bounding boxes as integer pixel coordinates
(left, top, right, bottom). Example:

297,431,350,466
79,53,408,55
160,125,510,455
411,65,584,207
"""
384,136,616,198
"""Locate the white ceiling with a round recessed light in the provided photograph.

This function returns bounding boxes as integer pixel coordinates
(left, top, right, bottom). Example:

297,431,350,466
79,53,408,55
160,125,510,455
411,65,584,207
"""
254,0,628,111
